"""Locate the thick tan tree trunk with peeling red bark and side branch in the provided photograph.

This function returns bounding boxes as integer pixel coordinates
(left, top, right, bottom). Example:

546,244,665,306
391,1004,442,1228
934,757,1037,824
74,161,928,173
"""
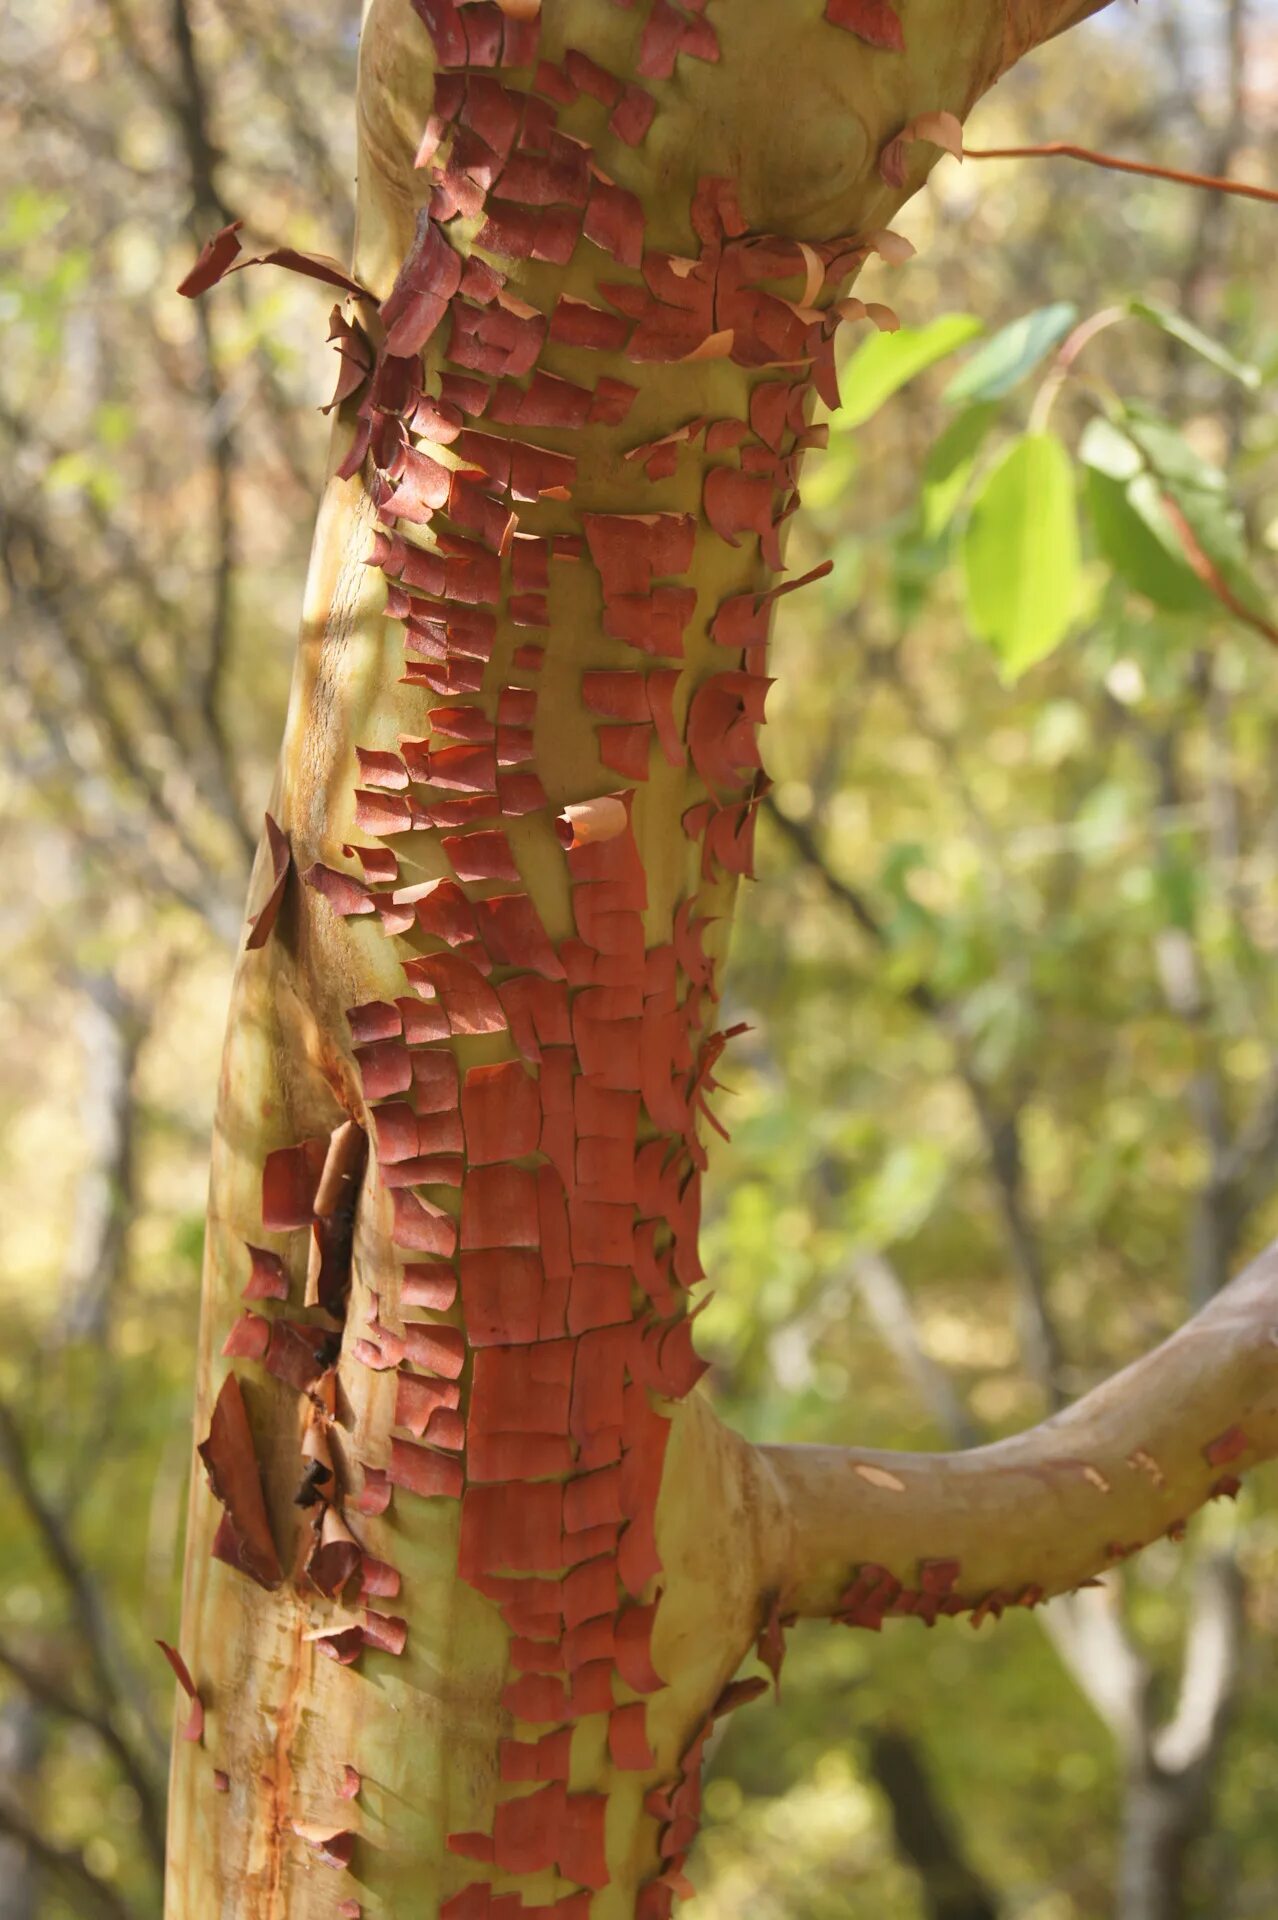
167,0,1278,1920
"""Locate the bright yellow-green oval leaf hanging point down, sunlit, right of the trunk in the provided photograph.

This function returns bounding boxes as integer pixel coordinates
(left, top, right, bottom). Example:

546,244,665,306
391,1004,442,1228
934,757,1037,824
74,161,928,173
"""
963,434,1082,680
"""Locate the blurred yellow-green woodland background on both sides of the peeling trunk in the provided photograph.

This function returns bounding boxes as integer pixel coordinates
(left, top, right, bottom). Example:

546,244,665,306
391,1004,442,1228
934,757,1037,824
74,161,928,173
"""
0,0,1278,1920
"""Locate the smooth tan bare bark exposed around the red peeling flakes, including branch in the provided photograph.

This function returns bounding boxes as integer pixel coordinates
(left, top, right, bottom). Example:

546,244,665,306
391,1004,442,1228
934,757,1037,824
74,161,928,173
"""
154,0,1278,1920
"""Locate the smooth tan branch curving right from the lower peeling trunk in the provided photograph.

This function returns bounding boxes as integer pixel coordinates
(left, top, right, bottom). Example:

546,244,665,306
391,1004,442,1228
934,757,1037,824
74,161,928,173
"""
762,1246,1278,1624
